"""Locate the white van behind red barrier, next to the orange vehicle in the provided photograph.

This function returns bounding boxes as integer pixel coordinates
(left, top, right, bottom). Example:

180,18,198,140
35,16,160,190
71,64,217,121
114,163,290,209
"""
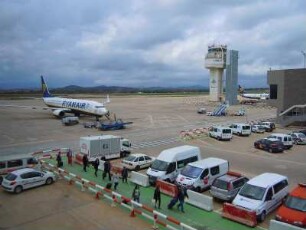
232,173,289,221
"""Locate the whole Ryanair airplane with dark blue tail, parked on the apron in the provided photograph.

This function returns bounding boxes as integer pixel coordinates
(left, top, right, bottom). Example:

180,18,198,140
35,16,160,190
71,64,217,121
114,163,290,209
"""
0,76,110,120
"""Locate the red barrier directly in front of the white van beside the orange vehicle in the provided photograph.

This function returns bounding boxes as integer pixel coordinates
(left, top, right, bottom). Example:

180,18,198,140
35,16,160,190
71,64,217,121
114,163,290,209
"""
222,203,257,227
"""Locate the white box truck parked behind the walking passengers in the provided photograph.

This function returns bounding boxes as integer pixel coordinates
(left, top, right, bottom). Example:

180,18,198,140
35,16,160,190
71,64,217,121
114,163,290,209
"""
80,135,130,161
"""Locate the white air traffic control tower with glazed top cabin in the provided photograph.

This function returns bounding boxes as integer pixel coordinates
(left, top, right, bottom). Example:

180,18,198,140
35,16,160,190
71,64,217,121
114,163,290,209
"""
205,45,227,101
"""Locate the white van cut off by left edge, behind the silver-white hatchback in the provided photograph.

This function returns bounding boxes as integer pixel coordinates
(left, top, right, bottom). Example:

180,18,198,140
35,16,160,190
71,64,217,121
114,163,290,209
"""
0,154,38,184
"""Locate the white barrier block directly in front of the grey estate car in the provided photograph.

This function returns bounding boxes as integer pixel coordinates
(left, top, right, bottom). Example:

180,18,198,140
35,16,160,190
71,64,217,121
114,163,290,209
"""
186,189,213,211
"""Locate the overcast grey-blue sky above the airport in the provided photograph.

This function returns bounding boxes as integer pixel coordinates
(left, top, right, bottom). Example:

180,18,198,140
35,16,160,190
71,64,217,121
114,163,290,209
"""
0,0,306,88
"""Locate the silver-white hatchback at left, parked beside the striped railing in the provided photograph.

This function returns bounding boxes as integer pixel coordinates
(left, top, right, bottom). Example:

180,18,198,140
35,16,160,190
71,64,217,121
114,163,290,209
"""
1,168,56,194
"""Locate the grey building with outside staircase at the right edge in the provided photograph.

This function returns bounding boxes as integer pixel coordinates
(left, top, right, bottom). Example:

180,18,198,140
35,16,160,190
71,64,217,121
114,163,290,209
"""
267,68,306,126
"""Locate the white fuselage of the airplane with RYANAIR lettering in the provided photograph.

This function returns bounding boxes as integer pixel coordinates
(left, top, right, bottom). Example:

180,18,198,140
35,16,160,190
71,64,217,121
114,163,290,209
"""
43,97,108,116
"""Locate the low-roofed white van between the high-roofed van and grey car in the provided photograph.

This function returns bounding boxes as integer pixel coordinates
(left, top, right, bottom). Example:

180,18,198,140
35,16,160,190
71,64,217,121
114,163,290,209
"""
176,157,229,192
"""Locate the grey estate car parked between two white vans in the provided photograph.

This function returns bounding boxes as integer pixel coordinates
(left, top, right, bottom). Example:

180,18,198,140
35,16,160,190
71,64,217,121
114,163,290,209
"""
210,171,249,201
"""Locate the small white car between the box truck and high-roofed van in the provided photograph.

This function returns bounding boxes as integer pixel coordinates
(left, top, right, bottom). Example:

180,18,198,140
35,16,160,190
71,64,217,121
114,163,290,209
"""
122,153,155,170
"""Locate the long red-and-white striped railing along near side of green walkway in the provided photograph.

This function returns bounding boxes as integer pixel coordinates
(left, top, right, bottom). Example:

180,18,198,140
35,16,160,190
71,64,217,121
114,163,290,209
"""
42,161,196,230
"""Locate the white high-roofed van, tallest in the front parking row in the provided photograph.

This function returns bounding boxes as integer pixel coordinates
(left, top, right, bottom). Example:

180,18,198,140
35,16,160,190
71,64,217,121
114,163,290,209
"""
147,145,201,185
